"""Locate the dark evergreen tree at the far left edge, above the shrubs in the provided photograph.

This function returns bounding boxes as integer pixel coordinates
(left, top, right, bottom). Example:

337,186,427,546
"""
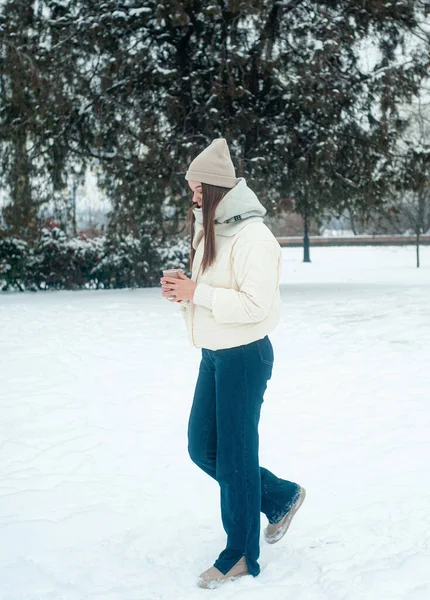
0,0,81,238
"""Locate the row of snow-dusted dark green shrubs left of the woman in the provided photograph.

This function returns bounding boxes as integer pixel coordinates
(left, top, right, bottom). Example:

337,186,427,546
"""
0,229,189,290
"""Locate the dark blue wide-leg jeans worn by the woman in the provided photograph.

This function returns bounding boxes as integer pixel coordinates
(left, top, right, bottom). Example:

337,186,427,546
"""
188,336,300,576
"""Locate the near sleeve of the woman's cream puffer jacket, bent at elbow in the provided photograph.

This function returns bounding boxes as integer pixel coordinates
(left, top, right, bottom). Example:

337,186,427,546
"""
194,241,281,325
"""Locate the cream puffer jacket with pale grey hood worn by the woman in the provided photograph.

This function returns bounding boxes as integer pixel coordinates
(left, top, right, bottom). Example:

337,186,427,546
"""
181,178,281,350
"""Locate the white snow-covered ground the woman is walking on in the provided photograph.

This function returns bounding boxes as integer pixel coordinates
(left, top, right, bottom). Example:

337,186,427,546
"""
0,247,430,600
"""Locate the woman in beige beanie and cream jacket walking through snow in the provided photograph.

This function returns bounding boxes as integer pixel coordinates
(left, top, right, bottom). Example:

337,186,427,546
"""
161,139,305,588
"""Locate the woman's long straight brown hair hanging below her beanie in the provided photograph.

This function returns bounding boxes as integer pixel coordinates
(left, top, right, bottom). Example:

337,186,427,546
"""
187,183,230,273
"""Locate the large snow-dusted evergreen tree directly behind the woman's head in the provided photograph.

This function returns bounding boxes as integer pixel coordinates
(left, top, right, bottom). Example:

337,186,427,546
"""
65,0,428,236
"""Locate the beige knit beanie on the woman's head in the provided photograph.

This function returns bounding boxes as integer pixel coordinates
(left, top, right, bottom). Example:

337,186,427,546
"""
185,138,237,188
